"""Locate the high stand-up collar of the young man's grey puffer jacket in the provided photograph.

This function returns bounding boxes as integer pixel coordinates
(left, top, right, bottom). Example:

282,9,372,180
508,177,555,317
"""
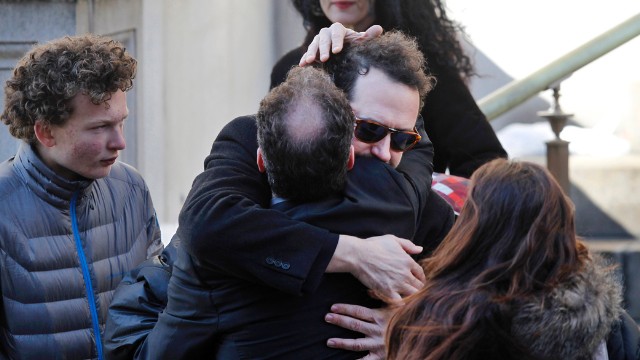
13,142,93,208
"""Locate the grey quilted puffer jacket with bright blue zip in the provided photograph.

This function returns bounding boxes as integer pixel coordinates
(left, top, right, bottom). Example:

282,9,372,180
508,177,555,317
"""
0,144,162,359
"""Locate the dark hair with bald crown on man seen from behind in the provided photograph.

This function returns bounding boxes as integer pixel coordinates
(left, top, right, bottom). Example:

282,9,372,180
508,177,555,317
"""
257,67,355,202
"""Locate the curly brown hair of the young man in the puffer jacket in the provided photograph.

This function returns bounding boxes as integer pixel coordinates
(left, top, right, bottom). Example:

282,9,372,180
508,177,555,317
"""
0,35,137,144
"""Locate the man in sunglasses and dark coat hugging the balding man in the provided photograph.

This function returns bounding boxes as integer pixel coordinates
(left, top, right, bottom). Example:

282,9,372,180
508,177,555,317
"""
178,33,453,356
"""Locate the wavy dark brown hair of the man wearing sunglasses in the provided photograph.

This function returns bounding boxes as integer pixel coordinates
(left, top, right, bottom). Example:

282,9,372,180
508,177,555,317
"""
324,31,435,109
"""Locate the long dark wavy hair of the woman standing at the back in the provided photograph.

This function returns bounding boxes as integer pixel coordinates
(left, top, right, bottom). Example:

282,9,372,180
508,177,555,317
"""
292,0,475,79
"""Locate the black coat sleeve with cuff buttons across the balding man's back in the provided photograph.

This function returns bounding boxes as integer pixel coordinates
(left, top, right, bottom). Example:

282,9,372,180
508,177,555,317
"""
178,117,338,294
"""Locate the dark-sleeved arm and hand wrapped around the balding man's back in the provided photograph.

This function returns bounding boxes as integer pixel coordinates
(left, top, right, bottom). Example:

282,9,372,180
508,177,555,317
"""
178,117,423,298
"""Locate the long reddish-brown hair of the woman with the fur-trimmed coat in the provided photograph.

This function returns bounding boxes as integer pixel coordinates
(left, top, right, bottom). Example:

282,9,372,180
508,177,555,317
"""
387,159,588,360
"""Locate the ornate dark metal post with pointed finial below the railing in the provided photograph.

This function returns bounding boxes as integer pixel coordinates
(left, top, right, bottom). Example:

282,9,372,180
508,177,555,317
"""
538,83,573,195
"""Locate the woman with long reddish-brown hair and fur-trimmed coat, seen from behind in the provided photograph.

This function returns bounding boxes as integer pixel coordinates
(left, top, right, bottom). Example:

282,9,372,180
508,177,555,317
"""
387,159,640,360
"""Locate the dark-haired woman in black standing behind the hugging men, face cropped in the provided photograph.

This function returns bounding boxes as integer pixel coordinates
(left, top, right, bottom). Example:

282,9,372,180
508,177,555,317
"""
271,0,507,177
